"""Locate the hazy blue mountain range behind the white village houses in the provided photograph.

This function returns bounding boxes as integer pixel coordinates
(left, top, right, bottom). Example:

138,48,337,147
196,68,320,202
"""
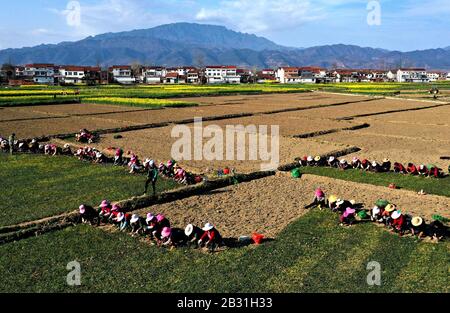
0,23,450,70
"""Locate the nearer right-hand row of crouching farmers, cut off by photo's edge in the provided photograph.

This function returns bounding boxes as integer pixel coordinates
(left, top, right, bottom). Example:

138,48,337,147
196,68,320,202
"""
307,188,449,241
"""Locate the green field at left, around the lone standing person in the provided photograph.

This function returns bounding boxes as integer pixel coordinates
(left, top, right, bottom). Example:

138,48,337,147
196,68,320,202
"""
0,153,177,226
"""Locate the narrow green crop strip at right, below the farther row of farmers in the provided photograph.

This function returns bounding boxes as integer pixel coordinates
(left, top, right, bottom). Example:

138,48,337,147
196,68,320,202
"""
300,167,450,197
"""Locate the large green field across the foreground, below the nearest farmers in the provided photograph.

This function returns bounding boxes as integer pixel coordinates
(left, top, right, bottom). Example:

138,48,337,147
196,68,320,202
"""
0,211,450,292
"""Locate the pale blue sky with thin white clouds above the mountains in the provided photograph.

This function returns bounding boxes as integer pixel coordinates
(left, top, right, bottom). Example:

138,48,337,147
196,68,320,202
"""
0,0,450,51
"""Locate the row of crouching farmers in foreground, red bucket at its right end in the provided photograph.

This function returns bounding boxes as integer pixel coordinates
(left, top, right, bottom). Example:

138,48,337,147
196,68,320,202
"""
79,200,224,251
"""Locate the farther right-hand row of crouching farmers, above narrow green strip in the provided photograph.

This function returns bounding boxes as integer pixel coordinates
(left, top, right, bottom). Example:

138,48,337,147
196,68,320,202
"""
298,155,450,178
